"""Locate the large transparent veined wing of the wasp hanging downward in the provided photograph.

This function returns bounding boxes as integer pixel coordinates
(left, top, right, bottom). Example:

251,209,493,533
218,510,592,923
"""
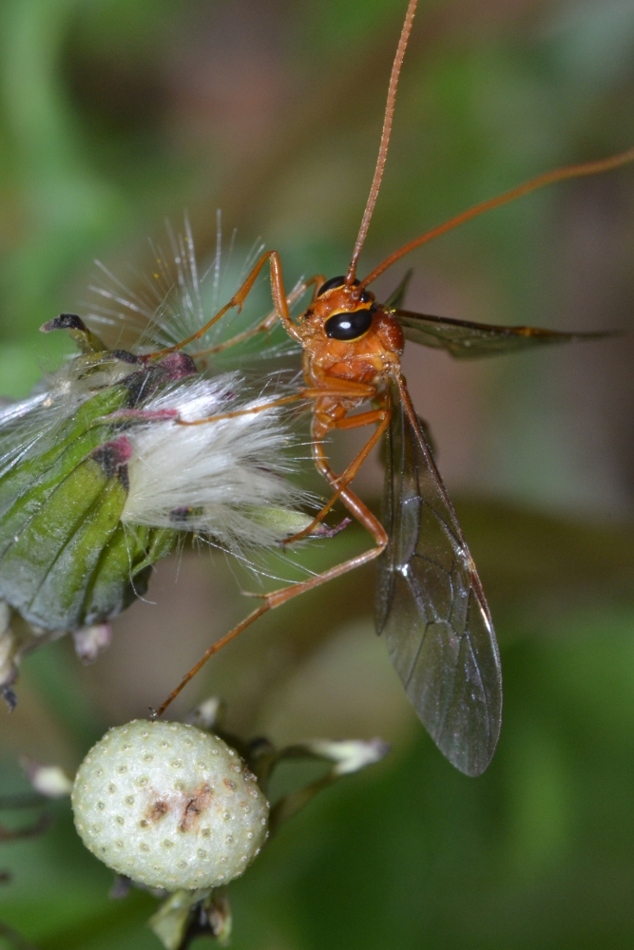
377,378,502,775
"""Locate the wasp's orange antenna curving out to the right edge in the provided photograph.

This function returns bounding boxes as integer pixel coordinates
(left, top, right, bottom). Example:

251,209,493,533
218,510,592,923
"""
359,148,634,289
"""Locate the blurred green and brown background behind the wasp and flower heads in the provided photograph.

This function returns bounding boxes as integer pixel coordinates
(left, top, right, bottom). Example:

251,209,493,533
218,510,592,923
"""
0,0,634,950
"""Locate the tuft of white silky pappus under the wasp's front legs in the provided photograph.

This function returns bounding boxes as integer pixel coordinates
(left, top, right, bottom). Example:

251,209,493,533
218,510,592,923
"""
122,373,311,554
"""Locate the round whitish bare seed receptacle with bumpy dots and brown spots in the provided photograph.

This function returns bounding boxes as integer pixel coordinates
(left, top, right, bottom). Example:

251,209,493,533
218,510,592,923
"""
72,720,269,891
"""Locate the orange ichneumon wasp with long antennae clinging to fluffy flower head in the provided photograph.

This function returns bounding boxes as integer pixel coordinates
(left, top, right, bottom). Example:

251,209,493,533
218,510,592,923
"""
149,0,634,775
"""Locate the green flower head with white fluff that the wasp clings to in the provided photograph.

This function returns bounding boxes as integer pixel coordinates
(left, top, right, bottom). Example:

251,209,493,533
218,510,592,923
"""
0,314,311,699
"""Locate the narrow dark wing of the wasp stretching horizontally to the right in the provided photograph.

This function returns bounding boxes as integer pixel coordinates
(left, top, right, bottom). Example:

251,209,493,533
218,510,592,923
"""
391,309,615,359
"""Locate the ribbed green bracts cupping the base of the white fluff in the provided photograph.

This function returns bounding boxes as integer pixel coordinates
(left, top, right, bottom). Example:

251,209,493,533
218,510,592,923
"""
0,376,177,630
